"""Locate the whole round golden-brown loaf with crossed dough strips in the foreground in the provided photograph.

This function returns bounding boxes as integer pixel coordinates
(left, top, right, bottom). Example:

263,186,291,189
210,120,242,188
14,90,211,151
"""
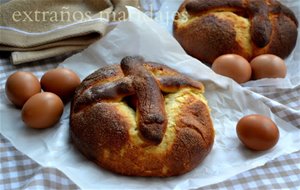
70,57,214,177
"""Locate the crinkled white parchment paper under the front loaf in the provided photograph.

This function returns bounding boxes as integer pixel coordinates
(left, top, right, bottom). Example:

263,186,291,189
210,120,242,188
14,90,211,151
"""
0,7,300,190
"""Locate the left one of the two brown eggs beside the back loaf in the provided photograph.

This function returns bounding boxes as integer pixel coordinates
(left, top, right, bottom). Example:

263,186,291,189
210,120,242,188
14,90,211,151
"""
212,54,251,83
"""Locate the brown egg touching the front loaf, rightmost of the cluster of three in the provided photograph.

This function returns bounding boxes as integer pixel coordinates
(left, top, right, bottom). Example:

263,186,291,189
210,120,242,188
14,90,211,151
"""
41,68,80,102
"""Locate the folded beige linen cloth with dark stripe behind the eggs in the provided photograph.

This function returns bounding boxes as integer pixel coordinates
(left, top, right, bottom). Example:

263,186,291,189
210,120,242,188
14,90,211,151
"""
0,0,139,64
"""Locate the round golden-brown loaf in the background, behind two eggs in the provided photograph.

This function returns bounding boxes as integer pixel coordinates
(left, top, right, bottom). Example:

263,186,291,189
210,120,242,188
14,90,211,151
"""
173,0,298,63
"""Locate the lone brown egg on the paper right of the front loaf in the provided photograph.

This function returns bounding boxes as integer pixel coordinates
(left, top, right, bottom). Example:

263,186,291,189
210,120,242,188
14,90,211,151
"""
236,114,279,150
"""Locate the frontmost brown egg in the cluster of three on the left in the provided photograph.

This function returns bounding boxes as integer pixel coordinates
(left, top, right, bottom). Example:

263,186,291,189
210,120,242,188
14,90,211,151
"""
22,92,64,129
